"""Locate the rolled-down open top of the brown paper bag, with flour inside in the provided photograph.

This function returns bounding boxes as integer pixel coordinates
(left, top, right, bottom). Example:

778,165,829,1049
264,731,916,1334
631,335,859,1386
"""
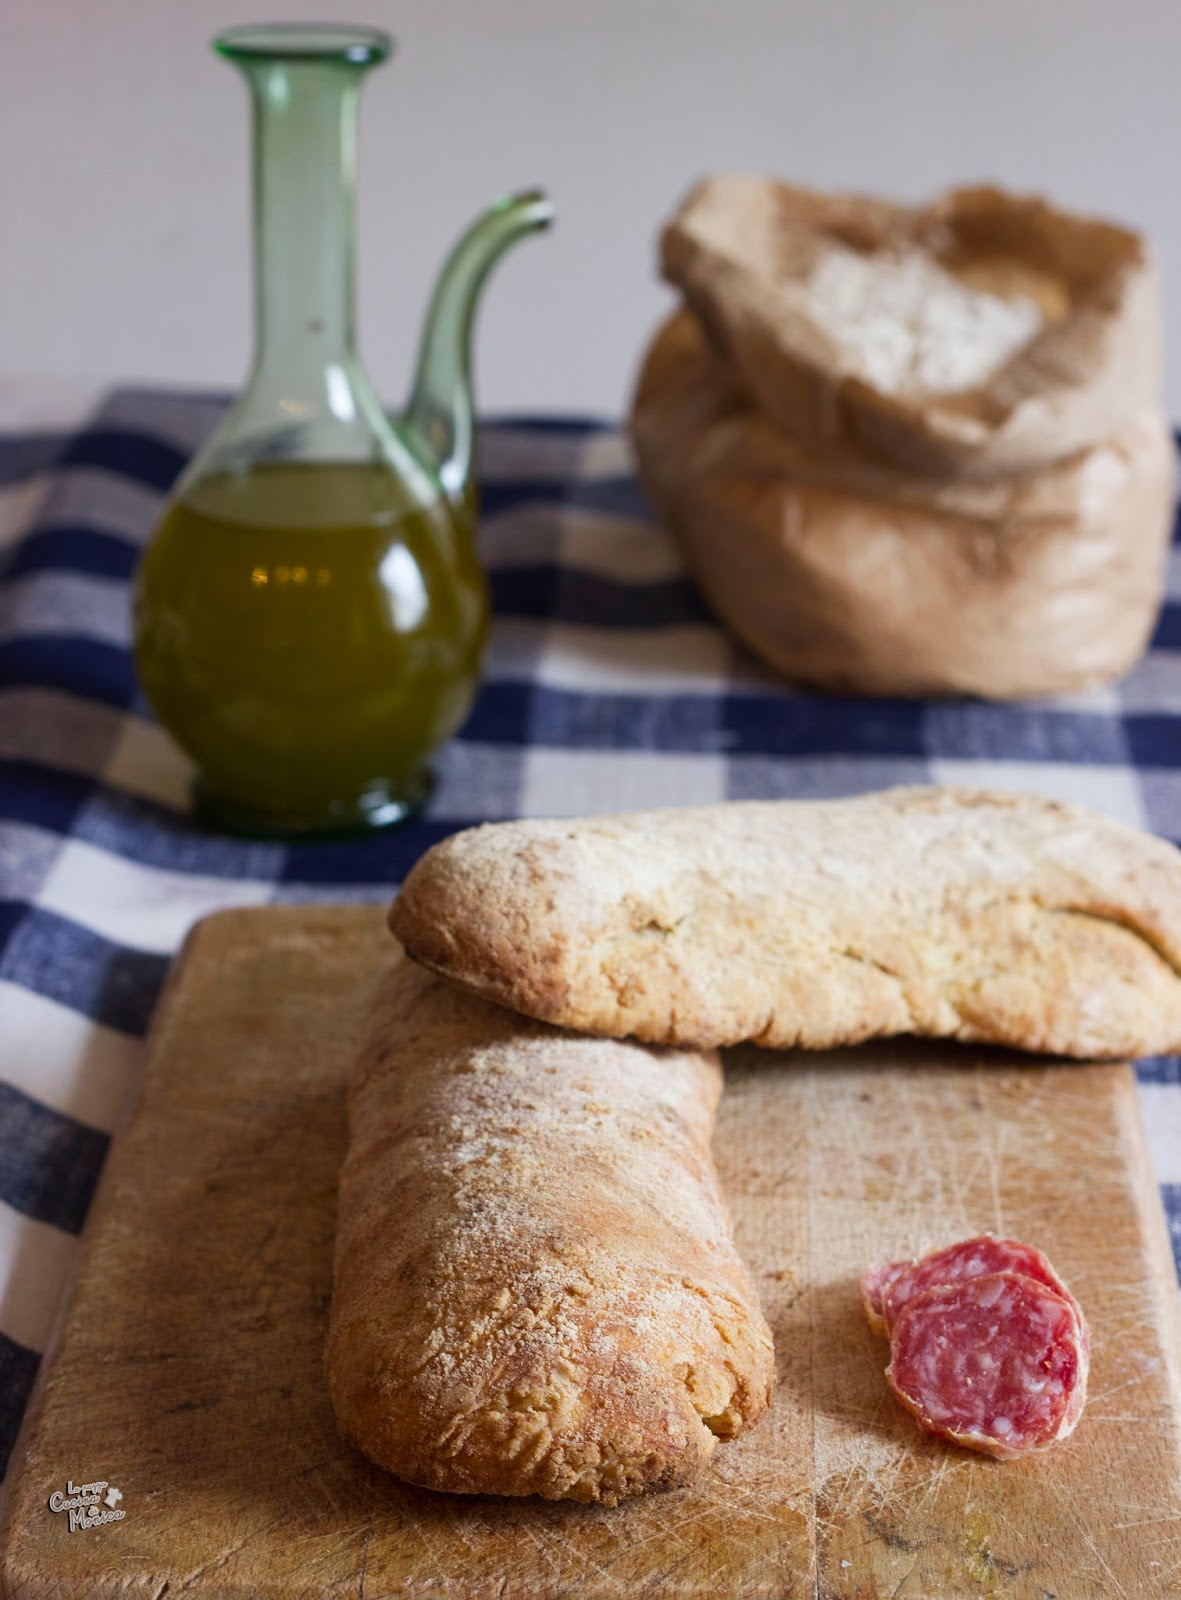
661,176,1160,477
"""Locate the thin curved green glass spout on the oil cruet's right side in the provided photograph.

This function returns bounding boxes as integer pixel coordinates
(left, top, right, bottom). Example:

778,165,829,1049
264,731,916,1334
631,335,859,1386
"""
398,189,554,512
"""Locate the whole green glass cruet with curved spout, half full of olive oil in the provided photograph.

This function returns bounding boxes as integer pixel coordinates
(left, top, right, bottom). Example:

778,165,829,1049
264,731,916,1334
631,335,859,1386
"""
134,26,552,835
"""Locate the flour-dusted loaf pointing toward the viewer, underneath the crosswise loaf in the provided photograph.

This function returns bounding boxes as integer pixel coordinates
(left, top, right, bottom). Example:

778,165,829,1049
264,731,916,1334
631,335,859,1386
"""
326,960,775,1504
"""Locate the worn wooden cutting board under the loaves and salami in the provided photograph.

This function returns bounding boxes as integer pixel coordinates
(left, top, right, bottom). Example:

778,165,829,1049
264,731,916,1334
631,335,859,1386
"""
0,909,1181,1600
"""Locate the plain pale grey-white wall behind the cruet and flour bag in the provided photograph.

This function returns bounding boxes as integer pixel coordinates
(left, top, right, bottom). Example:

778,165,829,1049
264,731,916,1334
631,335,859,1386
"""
0,0,1181,418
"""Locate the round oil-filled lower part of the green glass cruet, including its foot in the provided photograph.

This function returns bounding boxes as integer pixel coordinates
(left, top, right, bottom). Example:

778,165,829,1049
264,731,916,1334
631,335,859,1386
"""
136,462,488,832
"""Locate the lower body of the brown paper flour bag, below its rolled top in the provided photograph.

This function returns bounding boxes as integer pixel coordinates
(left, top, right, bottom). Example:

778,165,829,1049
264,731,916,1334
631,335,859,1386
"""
632,312,1173,698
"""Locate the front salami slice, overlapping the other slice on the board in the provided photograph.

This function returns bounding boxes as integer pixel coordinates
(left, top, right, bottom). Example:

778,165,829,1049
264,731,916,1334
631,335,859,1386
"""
887,1272,1088,1459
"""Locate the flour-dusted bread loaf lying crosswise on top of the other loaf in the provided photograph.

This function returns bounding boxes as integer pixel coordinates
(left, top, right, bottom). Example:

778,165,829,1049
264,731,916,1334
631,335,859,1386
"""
390,787,1181,1059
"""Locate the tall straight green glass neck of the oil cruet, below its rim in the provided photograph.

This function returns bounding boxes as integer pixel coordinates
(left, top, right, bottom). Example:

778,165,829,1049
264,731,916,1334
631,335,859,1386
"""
250,61,360,390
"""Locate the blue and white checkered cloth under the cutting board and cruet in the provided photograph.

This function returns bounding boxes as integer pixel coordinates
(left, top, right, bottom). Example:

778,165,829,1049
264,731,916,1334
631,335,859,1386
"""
0,392,1181,1467
